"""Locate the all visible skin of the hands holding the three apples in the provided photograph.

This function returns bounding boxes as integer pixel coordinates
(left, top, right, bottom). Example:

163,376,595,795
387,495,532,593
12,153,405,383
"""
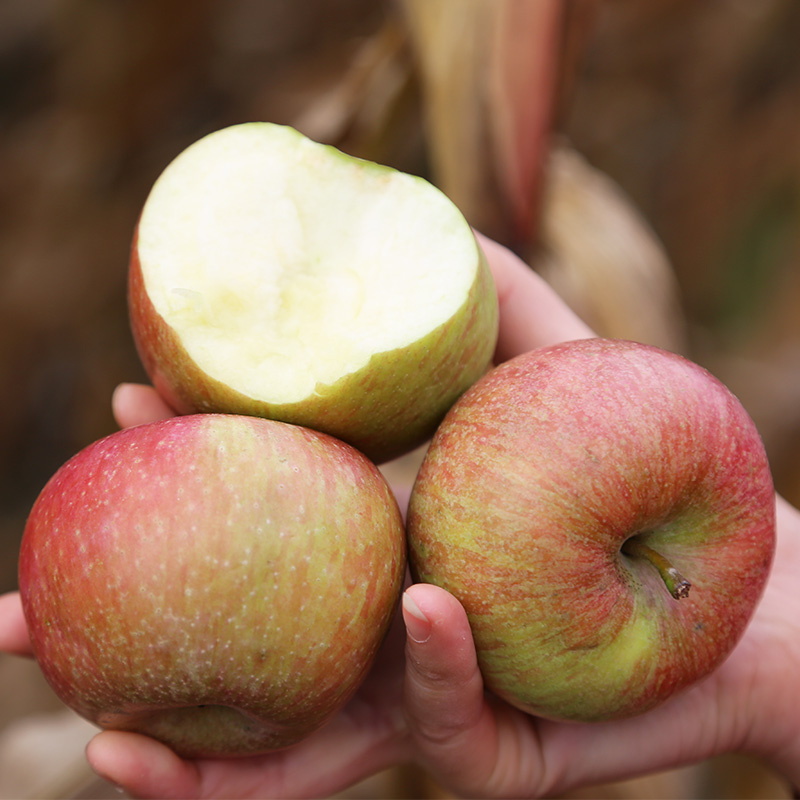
0,234,800,797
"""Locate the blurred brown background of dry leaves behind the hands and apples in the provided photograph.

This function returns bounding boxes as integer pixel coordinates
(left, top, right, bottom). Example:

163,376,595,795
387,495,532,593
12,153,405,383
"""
0,0,800,798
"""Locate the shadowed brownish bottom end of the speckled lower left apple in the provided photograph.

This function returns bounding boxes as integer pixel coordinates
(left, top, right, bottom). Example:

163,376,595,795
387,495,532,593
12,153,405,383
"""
96,705,310,758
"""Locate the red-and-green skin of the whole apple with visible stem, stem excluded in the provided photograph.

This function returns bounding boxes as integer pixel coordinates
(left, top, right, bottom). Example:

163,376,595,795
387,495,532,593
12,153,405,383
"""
408,339,775,722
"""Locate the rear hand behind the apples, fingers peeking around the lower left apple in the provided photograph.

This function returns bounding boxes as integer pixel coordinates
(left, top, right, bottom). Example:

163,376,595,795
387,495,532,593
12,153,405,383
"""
0,230,591,797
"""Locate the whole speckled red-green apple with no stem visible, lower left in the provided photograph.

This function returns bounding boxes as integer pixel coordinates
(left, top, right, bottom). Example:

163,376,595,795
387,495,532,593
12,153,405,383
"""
19,414,405,757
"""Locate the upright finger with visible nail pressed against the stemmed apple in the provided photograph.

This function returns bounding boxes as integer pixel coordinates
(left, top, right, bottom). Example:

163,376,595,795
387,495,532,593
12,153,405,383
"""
403,584,498,793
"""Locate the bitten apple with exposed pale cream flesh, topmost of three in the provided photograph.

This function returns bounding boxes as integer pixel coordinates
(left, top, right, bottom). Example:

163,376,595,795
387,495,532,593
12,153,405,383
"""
129,122,497,462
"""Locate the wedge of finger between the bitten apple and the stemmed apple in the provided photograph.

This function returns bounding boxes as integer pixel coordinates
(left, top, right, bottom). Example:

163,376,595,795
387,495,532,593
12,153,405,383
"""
476,234,595,363
